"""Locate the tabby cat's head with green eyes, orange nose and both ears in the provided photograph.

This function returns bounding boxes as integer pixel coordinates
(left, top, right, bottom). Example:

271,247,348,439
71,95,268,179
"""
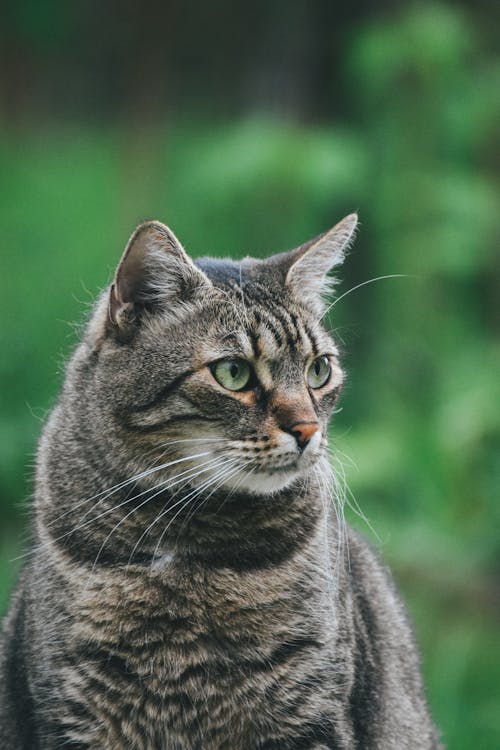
81,214,357,502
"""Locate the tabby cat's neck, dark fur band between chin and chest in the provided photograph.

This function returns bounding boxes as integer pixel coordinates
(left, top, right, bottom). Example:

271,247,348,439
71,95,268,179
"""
36,444,324,570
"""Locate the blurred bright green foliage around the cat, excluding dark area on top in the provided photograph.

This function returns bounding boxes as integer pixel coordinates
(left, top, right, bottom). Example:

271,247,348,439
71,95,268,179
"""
0,5,500,750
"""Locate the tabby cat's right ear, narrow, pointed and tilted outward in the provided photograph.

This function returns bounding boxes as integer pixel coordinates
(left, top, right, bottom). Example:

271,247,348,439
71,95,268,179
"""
285,214,358,315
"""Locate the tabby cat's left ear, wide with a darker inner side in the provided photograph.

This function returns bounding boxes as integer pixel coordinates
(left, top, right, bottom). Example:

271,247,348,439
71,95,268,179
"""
108,221,211,332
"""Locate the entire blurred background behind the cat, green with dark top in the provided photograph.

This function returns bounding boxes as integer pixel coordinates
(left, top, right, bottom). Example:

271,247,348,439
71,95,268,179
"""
0,0,500,750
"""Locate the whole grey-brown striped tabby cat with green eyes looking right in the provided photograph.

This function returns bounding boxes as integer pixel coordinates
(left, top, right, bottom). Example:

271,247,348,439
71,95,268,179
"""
0,214,441,750
